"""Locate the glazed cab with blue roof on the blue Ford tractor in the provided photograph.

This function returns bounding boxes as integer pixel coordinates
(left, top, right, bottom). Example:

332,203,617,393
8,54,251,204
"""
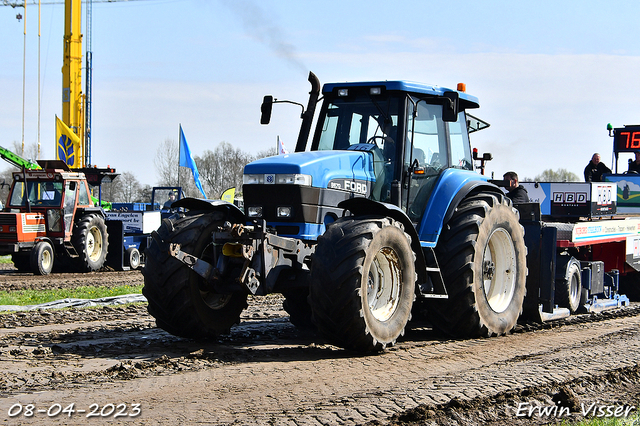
311,81,488,224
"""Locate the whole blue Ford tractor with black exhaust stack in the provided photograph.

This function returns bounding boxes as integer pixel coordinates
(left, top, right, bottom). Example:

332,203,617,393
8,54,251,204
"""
143,73,527,351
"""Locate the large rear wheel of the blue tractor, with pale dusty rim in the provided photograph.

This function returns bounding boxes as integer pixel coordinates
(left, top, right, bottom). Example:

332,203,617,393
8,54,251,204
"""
427,194,527,338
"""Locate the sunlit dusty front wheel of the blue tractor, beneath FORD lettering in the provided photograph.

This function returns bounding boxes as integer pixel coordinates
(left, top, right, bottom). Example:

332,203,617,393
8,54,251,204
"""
309,217,416,352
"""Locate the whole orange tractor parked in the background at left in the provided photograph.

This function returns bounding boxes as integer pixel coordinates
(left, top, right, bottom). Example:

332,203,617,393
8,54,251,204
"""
0,161,108,275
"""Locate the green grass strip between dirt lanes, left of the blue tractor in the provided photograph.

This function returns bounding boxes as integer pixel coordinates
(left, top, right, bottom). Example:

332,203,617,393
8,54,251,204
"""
0,285,143,306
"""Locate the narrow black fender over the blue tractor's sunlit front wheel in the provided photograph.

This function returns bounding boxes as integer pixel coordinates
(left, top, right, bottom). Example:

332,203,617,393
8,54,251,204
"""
338,197,427,282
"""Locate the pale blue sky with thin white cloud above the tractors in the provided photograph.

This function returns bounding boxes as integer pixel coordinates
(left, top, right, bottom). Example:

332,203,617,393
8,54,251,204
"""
0,0,640,190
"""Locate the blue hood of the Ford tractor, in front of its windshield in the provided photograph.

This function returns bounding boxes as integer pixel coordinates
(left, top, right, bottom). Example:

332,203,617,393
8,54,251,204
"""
244,149,383,192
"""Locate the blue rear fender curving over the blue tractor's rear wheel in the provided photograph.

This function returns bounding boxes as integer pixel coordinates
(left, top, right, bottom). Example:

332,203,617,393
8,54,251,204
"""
419,169,504,247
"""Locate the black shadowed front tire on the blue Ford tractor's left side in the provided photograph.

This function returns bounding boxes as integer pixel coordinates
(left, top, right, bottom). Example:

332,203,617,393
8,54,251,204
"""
142,212,248,339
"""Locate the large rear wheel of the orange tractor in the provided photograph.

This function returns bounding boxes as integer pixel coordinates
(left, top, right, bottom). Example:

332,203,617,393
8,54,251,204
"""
71,214,109,272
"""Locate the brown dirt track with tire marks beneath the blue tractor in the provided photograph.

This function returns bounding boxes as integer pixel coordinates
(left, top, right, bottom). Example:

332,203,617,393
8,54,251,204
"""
0,264,640,425
